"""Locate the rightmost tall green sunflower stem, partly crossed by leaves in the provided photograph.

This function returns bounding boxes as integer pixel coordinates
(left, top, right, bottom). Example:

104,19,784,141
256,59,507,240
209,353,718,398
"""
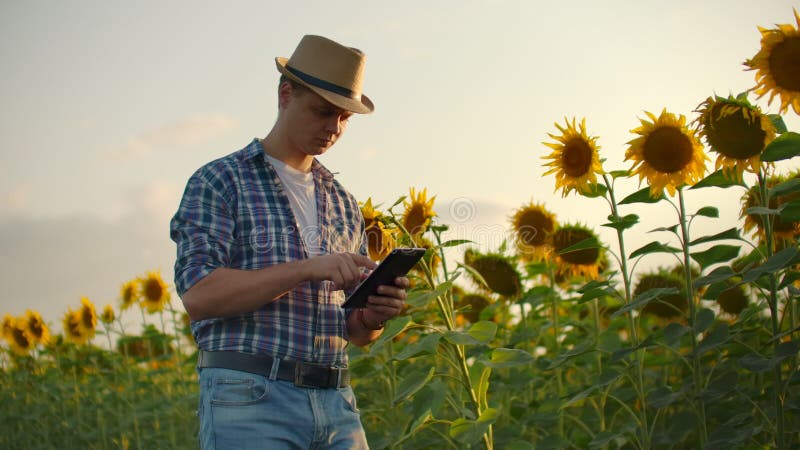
758,169,785,450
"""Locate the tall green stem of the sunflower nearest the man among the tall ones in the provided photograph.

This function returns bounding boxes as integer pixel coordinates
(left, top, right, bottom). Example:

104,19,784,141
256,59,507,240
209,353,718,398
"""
603,173,650,448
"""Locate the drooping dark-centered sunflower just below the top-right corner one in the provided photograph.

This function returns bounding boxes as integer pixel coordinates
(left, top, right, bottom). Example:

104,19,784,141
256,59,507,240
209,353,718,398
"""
696,96,777,179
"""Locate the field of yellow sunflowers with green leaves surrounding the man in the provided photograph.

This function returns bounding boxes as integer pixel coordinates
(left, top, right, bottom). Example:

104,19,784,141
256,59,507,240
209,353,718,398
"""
0,7,800,450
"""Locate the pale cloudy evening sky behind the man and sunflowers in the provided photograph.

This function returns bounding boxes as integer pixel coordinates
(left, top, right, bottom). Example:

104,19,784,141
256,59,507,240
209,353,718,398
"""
0,0,800,331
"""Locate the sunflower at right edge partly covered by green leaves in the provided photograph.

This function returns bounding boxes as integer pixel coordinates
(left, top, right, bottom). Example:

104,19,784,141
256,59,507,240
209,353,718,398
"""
739,171,800,241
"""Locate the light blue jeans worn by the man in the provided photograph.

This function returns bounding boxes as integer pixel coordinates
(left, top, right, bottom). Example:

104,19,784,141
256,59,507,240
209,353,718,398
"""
197,368,369,450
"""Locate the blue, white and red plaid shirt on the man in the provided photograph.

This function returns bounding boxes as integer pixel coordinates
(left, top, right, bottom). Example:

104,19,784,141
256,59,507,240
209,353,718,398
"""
170,139,366,365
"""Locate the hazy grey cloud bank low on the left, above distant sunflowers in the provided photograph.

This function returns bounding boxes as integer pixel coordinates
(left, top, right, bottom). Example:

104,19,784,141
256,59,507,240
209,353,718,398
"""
0,182,181,333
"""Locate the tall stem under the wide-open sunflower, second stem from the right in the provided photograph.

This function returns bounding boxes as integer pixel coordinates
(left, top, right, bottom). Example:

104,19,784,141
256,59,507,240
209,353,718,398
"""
677,187,708,447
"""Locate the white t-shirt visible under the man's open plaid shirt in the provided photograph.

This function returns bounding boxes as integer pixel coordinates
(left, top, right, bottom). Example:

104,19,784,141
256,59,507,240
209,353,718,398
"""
267,155,322,257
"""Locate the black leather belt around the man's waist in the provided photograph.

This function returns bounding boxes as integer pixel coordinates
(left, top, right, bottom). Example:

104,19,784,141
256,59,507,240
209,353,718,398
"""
197,350,350,389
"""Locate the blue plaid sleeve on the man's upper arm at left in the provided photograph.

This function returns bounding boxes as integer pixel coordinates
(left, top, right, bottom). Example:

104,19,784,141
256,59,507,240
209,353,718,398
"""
170,168,235,296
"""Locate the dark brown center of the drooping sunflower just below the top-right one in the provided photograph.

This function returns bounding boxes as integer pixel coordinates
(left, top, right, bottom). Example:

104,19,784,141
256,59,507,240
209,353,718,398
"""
708,104,767,159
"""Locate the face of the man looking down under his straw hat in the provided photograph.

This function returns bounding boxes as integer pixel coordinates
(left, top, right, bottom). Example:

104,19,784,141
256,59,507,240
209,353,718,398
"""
280,83,352,156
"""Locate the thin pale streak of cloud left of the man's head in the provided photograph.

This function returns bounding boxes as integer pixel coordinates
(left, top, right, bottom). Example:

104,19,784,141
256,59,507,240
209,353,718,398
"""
106,115,236,161
